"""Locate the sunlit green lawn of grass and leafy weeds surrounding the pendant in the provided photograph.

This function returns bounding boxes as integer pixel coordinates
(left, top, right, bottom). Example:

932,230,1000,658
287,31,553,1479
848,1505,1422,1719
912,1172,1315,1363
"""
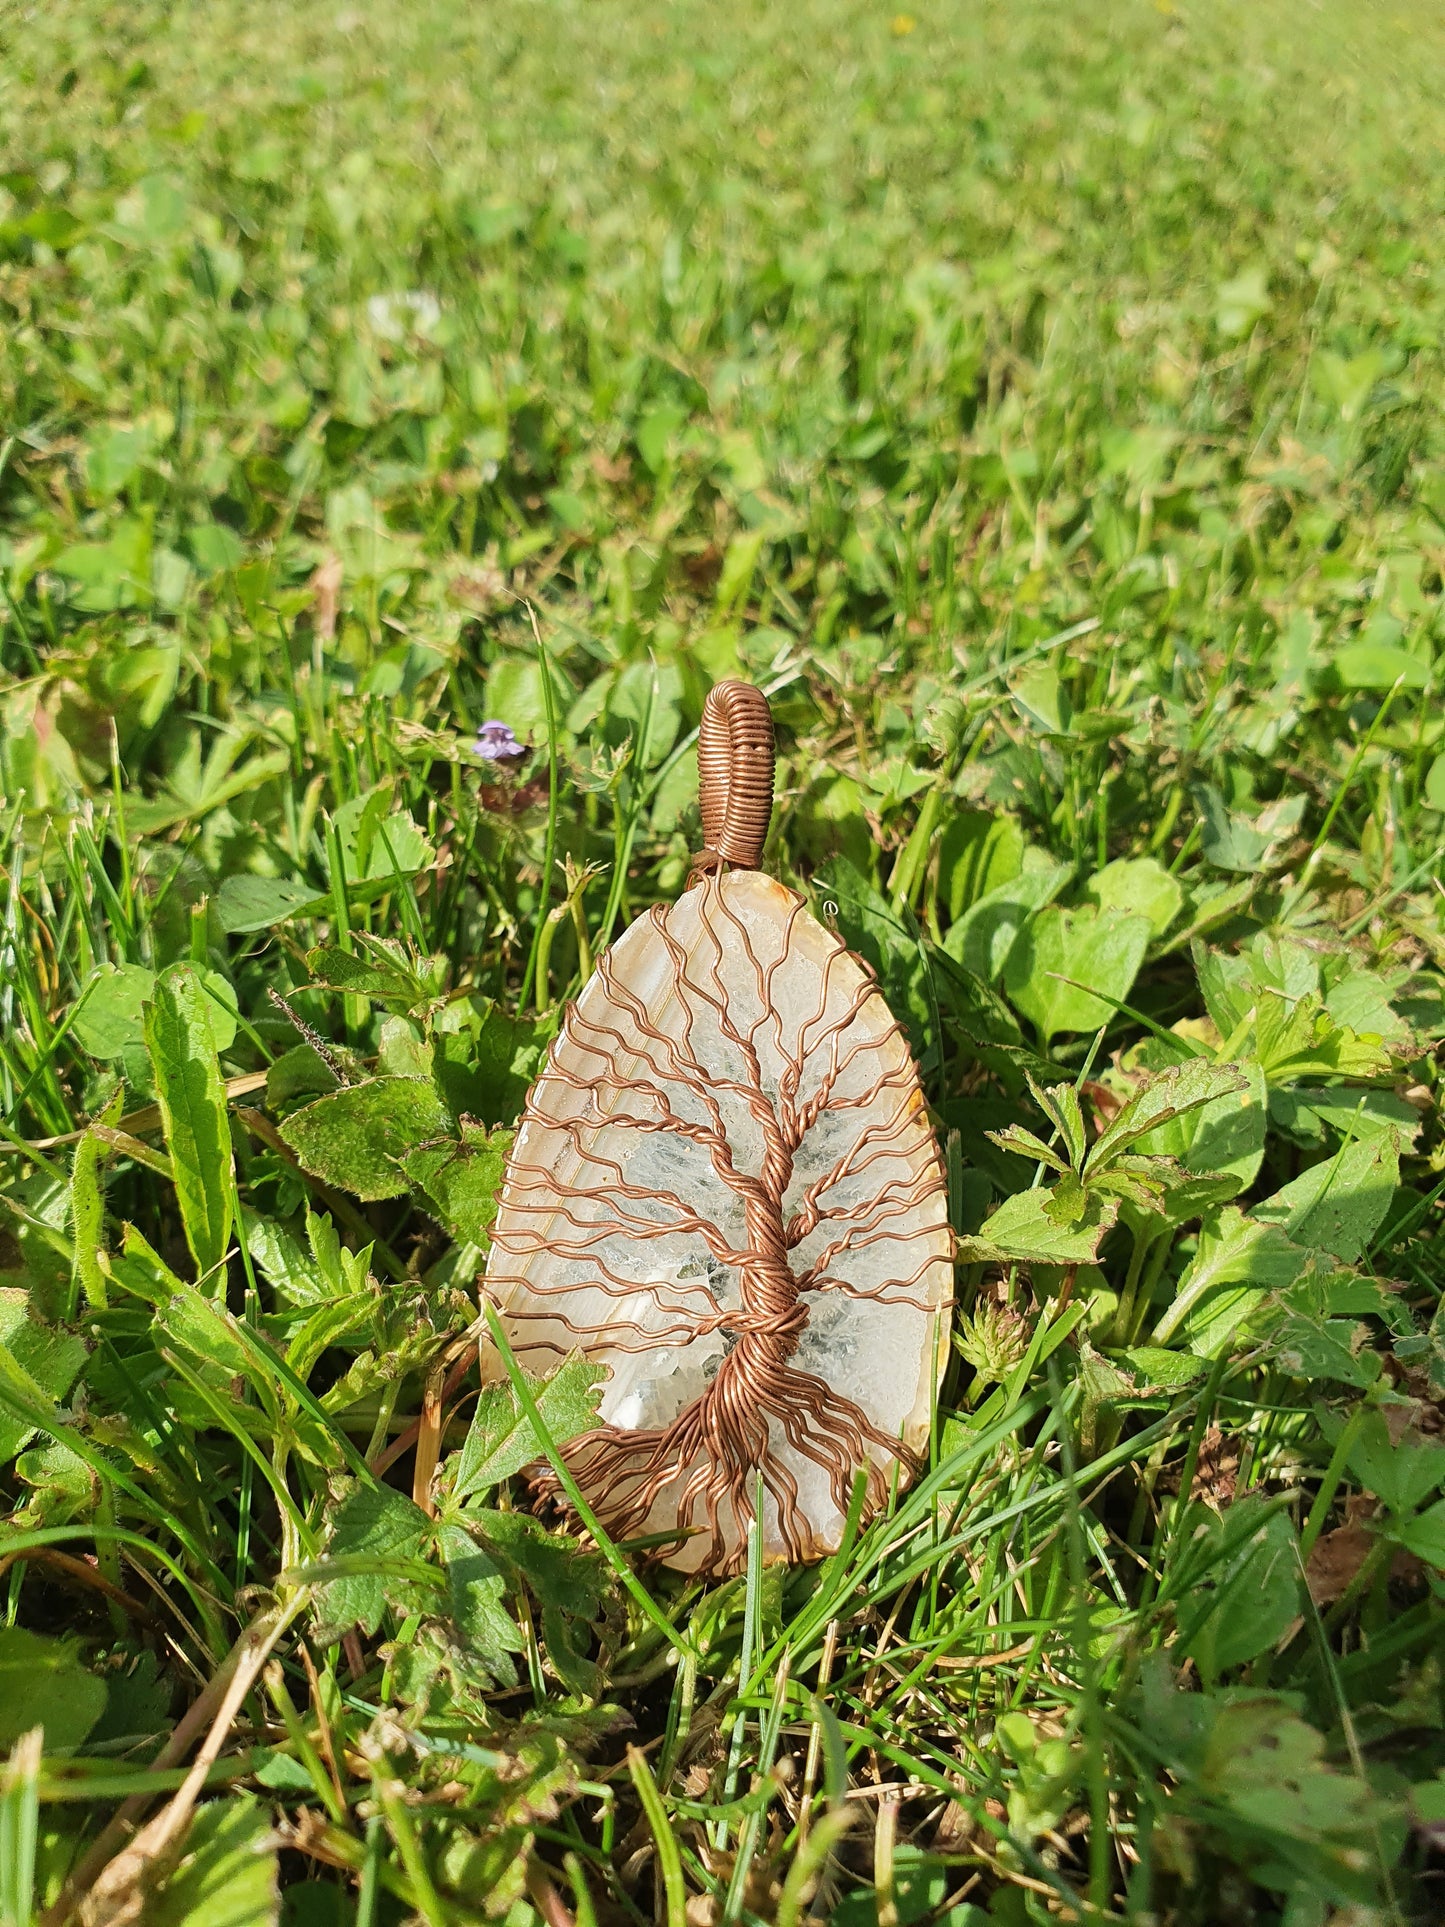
0,0,1445,1927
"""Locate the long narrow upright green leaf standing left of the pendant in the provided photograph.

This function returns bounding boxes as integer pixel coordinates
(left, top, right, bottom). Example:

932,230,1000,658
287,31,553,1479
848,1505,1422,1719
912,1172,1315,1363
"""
145,964,235,1278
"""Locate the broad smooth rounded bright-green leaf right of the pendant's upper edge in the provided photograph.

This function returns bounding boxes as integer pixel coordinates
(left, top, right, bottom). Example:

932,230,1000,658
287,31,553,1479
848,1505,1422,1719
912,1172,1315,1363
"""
1004,906,1150,1043
